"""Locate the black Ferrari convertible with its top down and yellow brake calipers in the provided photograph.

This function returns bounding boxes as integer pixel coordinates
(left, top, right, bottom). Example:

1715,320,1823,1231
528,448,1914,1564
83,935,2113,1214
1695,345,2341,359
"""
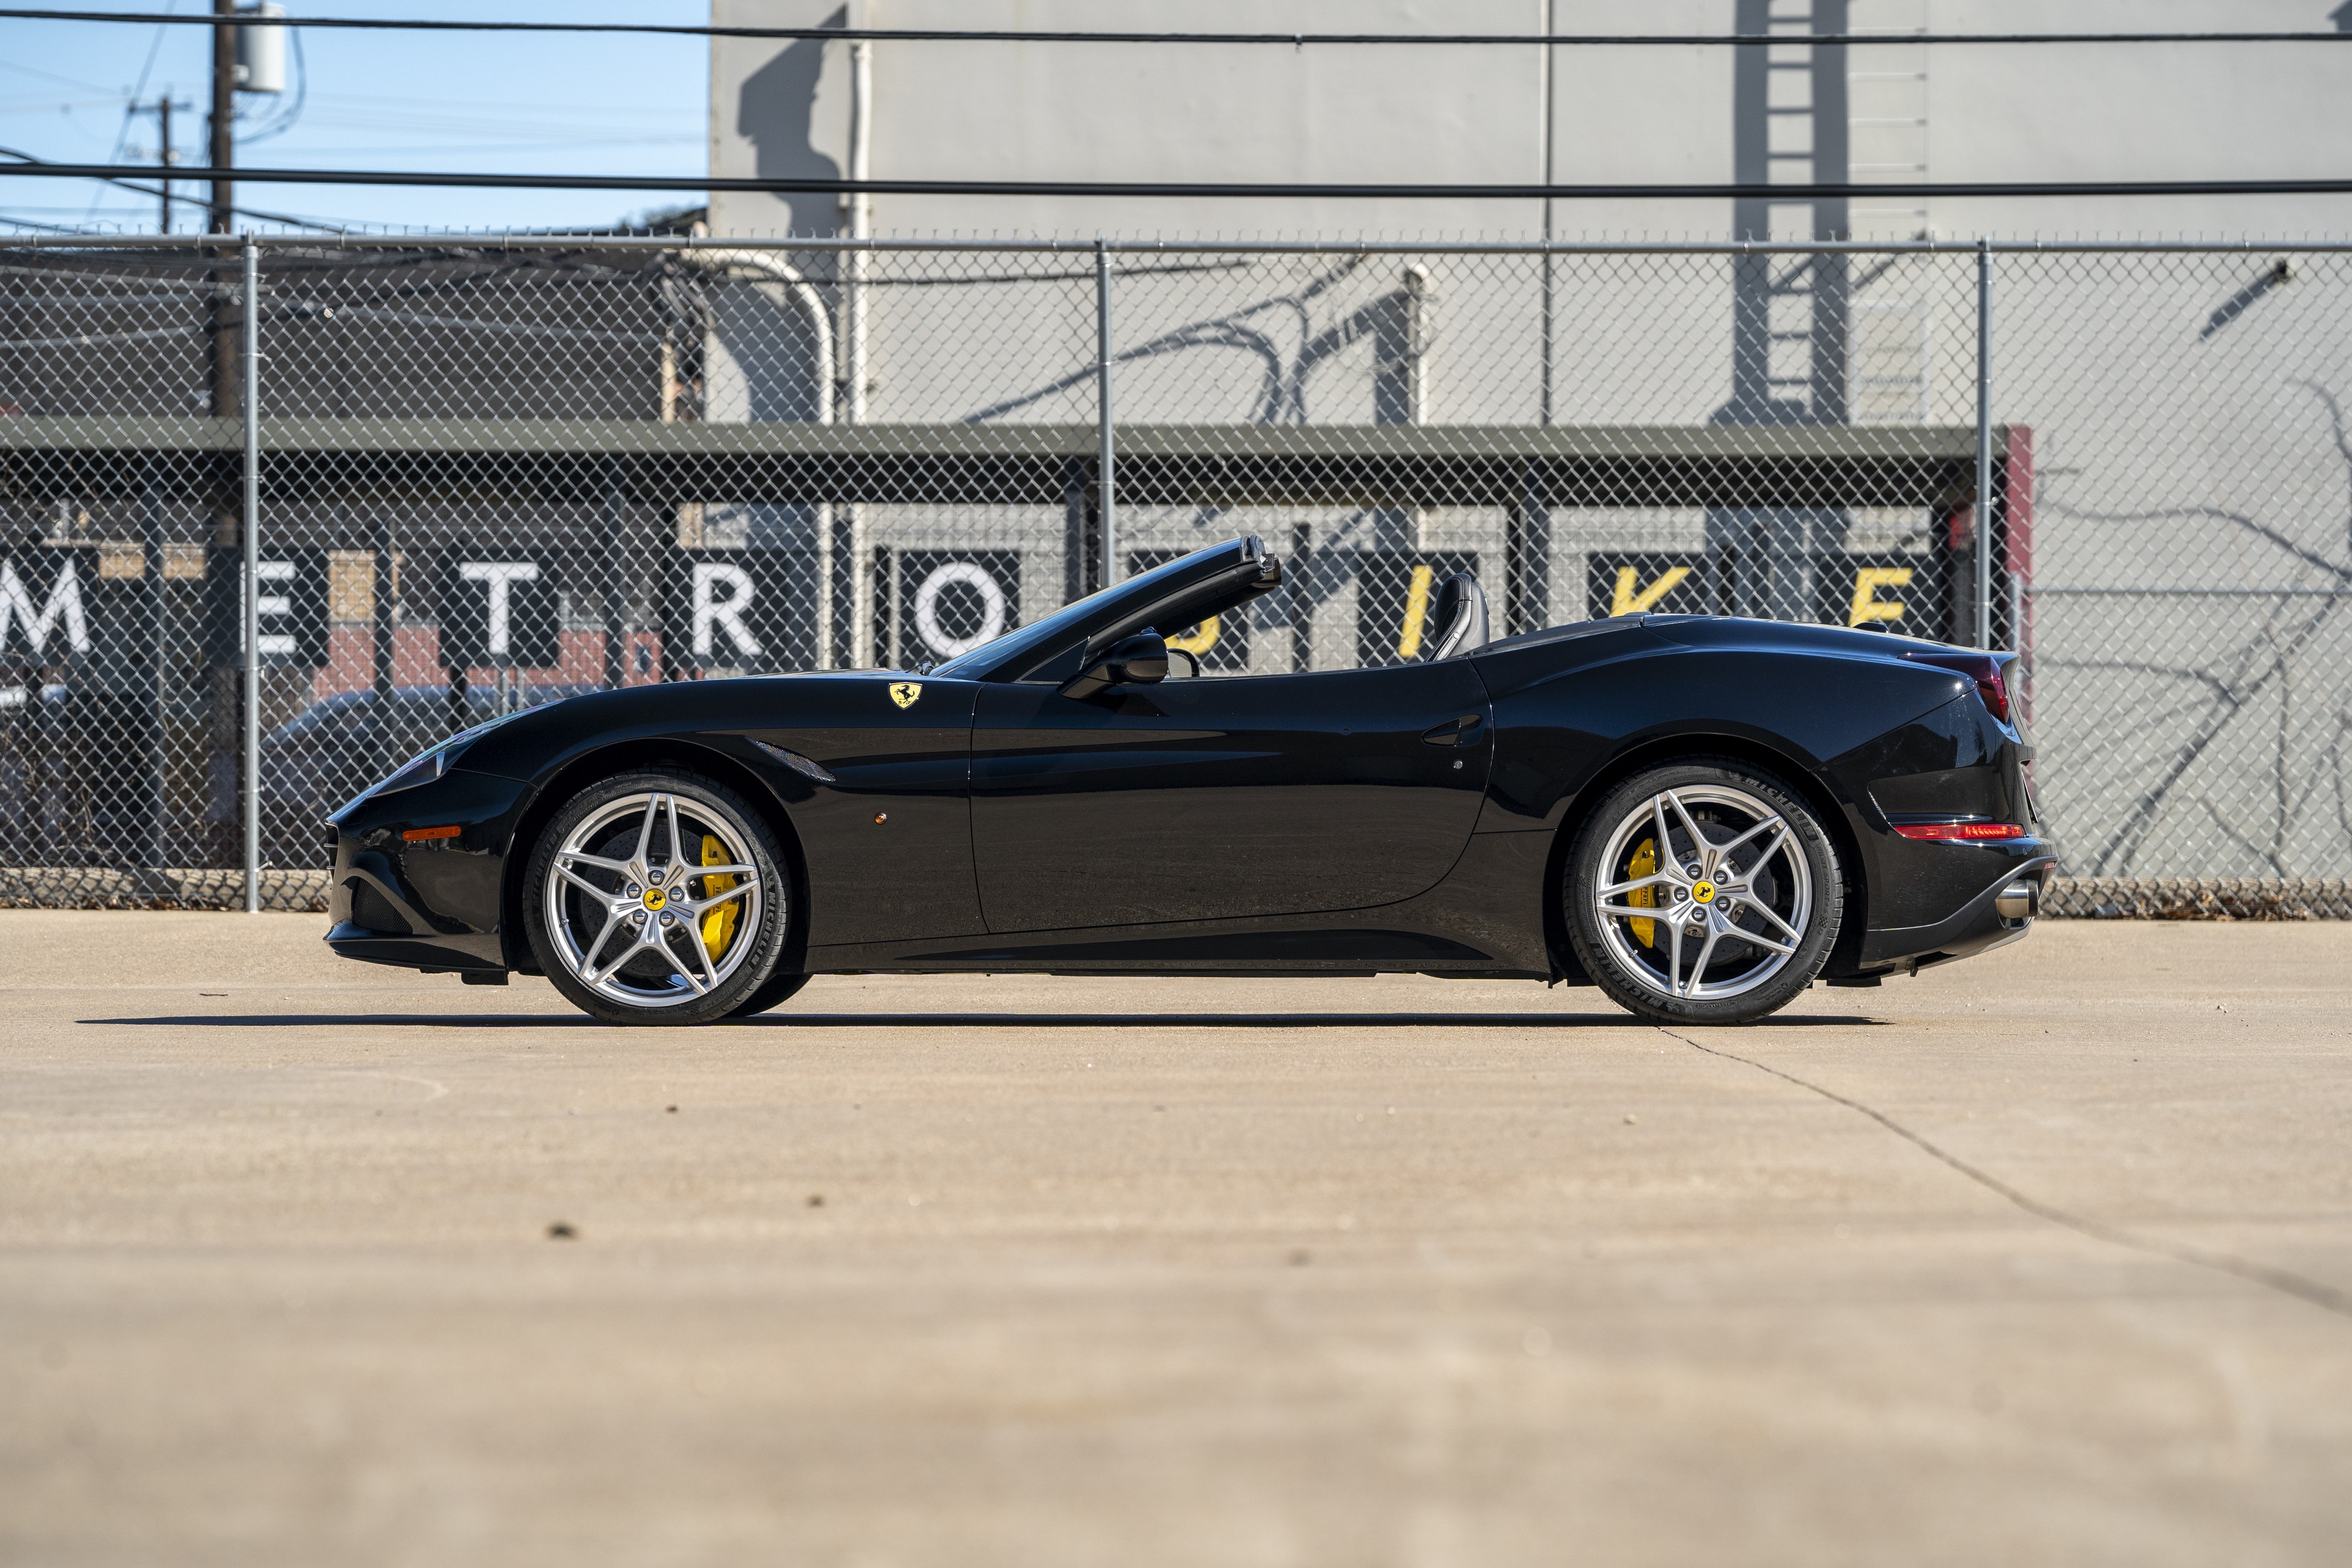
327,539,2053,1022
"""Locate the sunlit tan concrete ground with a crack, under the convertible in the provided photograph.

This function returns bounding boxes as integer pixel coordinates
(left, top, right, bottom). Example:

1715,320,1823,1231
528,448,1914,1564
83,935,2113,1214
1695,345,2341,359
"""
0,912,2352,1568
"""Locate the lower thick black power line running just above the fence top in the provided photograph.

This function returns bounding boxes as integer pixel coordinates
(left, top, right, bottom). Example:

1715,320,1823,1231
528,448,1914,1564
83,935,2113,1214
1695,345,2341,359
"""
14,153,2352,202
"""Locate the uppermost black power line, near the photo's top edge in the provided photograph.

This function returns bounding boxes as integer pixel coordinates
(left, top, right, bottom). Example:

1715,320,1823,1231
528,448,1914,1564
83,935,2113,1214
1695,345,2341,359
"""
0,7,2352,49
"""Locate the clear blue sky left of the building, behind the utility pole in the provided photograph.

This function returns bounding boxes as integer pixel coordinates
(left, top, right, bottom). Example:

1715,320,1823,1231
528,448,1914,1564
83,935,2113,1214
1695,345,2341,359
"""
0,0,710,233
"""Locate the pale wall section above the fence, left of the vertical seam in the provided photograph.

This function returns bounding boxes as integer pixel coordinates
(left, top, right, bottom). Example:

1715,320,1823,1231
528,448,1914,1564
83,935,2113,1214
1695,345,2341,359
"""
710,0,1543,238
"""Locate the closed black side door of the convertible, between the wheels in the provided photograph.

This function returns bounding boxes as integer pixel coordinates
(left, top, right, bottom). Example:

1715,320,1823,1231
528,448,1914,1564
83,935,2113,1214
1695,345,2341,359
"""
971,658,1491,931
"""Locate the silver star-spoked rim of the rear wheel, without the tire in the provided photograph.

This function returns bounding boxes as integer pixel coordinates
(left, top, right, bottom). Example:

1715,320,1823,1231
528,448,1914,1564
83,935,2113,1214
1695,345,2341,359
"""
1592,785,1813,1001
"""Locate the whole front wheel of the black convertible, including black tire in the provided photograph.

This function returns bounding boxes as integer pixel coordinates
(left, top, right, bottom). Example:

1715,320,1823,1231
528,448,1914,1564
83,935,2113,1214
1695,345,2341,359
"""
522,769,793,1025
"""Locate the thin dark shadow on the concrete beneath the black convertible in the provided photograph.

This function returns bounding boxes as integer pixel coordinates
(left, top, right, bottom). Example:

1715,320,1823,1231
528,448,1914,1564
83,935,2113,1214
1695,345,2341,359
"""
75,1013,1884,1029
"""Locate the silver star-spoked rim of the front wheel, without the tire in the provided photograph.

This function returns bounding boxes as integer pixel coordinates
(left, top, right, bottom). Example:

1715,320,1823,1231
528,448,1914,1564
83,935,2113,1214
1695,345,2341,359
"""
539,790,769,1008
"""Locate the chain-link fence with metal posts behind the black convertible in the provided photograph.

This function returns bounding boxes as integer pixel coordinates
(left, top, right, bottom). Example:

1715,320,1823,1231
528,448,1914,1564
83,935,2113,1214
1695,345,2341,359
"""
0,238,2352,917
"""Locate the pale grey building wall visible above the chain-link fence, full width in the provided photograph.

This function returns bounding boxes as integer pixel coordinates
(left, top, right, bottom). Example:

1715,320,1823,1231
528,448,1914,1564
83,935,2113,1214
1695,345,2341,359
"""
710,0,2352,238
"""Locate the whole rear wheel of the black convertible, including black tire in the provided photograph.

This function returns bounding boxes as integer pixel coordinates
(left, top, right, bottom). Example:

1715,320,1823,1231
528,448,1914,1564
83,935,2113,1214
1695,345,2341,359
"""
1562,757,1844,1025
